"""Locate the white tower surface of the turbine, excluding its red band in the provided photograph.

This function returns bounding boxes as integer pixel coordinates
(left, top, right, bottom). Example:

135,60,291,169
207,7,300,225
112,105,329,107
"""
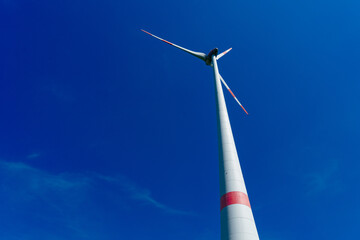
212,56,259,240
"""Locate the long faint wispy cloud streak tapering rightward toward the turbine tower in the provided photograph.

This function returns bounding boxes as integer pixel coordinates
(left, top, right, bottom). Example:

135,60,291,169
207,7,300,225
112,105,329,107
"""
0,161,195,215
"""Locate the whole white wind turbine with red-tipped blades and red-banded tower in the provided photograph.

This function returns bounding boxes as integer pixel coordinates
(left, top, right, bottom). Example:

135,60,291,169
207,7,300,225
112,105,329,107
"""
141,29,259,240
